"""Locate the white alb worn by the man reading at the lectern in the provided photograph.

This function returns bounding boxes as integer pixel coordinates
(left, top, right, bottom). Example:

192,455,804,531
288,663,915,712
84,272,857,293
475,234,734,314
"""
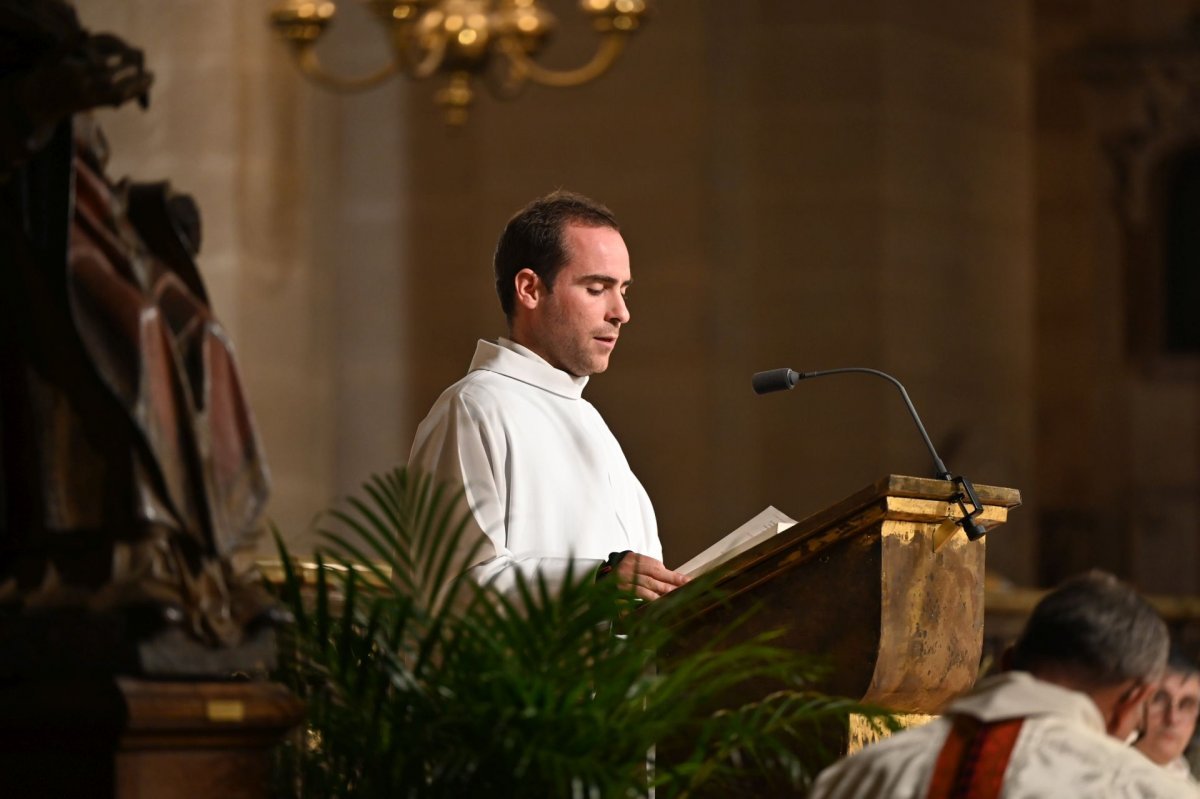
408,338,662,591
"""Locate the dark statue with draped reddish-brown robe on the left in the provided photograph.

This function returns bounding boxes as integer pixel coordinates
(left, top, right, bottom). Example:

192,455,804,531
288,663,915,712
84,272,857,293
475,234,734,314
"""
0,0,274,674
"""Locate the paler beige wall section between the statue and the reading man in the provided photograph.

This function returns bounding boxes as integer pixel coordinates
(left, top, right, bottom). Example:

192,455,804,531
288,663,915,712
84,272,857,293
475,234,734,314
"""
79,0,412,551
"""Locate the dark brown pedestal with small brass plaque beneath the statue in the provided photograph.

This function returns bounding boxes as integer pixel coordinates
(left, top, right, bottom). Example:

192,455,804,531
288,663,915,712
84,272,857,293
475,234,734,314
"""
0,678,304,799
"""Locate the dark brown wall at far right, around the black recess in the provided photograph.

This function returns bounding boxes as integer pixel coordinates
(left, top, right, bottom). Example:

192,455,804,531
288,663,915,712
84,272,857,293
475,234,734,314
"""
1036,0,1200,593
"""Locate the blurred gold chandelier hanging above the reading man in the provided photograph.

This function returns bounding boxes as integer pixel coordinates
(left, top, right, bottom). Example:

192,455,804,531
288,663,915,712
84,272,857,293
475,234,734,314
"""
271,0,646,125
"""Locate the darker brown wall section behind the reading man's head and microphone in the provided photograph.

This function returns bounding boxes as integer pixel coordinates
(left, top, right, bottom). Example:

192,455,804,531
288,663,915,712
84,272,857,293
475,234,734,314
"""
404,1,1036,578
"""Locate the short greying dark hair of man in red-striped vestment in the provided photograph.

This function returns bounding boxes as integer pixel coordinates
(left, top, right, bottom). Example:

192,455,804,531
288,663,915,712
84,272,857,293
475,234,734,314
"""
1010,571,1170,687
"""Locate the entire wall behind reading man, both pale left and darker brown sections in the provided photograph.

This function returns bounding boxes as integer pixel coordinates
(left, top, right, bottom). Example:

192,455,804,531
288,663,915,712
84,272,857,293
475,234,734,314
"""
80,0,1038,578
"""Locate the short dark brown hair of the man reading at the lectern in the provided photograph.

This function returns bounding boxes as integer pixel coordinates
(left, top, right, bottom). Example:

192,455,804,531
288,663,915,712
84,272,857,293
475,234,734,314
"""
493,190,620,322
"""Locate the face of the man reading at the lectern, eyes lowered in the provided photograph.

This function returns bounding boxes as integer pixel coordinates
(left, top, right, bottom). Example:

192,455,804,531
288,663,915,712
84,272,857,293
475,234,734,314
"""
521,224,631,377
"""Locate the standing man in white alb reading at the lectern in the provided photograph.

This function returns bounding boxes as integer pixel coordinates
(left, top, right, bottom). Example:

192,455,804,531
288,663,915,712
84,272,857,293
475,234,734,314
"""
409,191,686,600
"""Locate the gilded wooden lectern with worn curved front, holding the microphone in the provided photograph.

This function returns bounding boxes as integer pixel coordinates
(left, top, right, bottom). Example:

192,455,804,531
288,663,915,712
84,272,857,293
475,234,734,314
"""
678,475,1021,713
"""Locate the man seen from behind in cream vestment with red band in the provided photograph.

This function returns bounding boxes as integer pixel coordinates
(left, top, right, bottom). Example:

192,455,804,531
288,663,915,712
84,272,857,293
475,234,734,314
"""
810,572,1200,799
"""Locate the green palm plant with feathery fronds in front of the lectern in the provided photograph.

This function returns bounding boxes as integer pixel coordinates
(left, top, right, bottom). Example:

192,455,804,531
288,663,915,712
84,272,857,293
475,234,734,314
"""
276,469,888,799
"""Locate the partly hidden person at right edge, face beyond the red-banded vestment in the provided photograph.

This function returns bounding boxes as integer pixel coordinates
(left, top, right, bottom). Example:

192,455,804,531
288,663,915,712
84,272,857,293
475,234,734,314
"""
1134,650,1200,782
